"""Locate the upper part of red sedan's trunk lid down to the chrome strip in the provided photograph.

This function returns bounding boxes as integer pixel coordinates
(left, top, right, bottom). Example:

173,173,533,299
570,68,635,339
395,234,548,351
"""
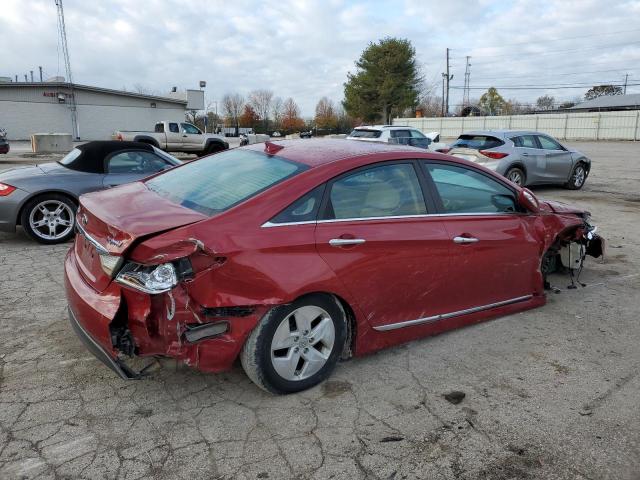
78,182,209,255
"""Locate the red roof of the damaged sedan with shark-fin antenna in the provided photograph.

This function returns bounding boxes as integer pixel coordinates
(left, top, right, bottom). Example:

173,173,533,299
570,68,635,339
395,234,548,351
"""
243,138,424,167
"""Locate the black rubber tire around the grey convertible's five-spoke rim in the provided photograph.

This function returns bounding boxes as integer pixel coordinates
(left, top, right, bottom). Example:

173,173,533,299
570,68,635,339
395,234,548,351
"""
20,193,78,245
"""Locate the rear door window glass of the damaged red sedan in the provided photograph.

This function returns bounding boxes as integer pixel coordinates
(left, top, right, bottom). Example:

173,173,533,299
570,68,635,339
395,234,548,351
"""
326,164,427,219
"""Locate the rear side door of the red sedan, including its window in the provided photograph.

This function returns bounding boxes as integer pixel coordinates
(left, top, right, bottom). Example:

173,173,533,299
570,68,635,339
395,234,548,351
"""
315,161,451,329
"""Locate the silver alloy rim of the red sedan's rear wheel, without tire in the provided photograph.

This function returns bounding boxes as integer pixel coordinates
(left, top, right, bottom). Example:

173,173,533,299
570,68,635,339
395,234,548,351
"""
271,305,336,381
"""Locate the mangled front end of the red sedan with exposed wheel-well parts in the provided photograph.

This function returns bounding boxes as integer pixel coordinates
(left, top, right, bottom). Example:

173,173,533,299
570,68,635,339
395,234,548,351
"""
541,210,605,290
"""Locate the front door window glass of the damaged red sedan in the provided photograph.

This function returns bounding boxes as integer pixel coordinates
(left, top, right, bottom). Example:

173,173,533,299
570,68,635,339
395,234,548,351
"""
426,163,517,214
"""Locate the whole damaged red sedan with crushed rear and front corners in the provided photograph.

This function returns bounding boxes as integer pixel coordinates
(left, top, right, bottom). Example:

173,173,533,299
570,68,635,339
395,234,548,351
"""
65,140,603,393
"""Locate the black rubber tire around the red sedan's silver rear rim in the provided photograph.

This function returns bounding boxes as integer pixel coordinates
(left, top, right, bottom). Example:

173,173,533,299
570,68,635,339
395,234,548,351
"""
240,294,347,394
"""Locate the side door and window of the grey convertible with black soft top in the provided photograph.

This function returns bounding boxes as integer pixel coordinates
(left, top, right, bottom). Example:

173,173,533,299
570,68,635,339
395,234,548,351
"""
102,150,173,188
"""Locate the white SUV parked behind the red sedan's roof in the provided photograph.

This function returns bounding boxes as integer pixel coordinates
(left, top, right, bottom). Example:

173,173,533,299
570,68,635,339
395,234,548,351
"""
347,125,447,151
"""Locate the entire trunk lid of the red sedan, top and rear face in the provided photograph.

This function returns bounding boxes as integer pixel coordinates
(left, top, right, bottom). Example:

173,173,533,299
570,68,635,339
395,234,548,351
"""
74,182,209,291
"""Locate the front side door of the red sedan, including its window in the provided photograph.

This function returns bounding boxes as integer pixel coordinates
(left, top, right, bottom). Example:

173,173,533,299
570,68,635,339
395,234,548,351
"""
423,161,541,311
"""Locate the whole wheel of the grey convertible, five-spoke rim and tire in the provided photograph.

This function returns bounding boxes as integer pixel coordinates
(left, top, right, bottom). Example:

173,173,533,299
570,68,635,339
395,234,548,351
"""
20,193,76,245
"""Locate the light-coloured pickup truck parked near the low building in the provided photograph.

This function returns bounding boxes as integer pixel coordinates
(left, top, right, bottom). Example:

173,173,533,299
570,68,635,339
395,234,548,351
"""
113,121,229,155
